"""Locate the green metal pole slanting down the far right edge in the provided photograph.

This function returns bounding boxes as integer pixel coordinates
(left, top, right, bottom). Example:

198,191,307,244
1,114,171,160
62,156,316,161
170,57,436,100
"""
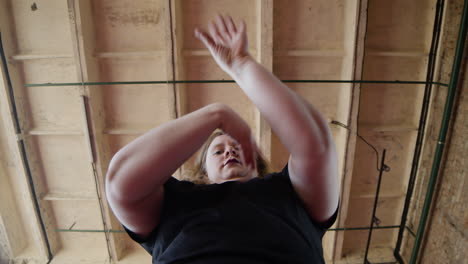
410,0,468,264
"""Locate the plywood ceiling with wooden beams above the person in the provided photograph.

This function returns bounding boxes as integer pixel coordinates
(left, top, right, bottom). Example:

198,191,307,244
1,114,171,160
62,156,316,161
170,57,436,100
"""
0,0,435,263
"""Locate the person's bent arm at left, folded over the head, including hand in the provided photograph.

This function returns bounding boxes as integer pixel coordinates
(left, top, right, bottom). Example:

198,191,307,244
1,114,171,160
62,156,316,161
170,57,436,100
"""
106,104,254,237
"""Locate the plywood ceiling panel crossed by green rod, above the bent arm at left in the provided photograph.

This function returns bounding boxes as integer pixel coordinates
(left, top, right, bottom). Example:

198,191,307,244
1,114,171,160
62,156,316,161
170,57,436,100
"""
100,57,171,128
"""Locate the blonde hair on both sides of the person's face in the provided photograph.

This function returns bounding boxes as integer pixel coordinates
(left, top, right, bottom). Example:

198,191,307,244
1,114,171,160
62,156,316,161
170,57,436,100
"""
190,129,270,184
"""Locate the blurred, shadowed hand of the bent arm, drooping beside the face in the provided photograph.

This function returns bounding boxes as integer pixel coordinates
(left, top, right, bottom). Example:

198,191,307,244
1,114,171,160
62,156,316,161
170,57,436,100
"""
217,103,258,169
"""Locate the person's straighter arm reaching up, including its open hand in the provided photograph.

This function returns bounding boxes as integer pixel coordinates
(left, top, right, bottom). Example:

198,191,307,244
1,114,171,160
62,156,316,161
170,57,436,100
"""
195,16,338,222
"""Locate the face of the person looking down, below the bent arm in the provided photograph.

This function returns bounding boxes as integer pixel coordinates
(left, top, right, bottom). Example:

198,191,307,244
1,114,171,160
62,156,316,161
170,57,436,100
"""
205,135,256,183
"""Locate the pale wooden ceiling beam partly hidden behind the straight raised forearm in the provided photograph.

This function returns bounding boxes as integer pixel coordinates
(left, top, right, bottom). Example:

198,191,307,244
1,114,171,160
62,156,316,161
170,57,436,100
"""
255,0,273,161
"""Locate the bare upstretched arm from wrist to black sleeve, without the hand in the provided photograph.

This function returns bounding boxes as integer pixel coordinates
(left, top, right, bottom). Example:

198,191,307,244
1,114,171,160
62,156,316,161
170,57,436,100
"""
233,57,338,222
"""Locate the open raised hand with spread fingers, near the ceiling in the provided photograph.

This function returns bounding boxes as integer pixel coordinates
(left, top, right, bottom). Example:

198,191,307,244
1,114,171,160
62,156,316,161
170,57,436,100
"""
195,15,250,75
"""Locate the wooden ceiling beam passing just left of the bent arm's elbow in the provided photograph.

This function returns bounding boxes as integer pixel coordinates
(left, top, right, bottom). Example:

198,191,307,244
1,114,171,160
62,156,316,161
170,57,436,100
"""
68,0,125,261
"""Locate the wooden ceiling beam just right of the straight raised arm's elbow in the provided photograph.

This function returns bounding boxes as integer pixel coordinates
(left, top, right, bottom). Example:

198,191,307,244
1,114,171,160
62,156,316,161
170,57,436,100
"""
333,0,368,261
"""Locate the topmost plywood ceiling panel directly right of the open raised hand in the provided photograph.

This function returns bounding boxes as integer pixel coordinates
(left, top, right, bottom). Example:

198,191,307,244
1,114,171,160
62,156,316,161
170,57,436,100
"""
273,0,346,50
